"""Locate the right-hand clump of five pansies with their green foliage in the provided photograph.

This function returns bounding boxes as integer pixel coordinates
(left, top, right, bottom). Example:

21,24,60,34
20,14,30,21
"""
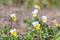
24,5,60,40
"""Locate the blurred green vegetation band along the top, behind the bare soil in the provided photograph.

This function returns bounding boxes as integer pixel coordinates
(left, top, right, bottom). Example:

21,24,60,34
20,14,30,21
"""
0,0,60,8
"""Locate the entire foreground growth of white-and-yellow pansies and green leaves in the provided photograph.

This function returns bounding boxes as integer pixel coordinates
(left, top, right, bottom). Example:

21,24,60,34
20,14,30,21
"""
0,5,60,40
